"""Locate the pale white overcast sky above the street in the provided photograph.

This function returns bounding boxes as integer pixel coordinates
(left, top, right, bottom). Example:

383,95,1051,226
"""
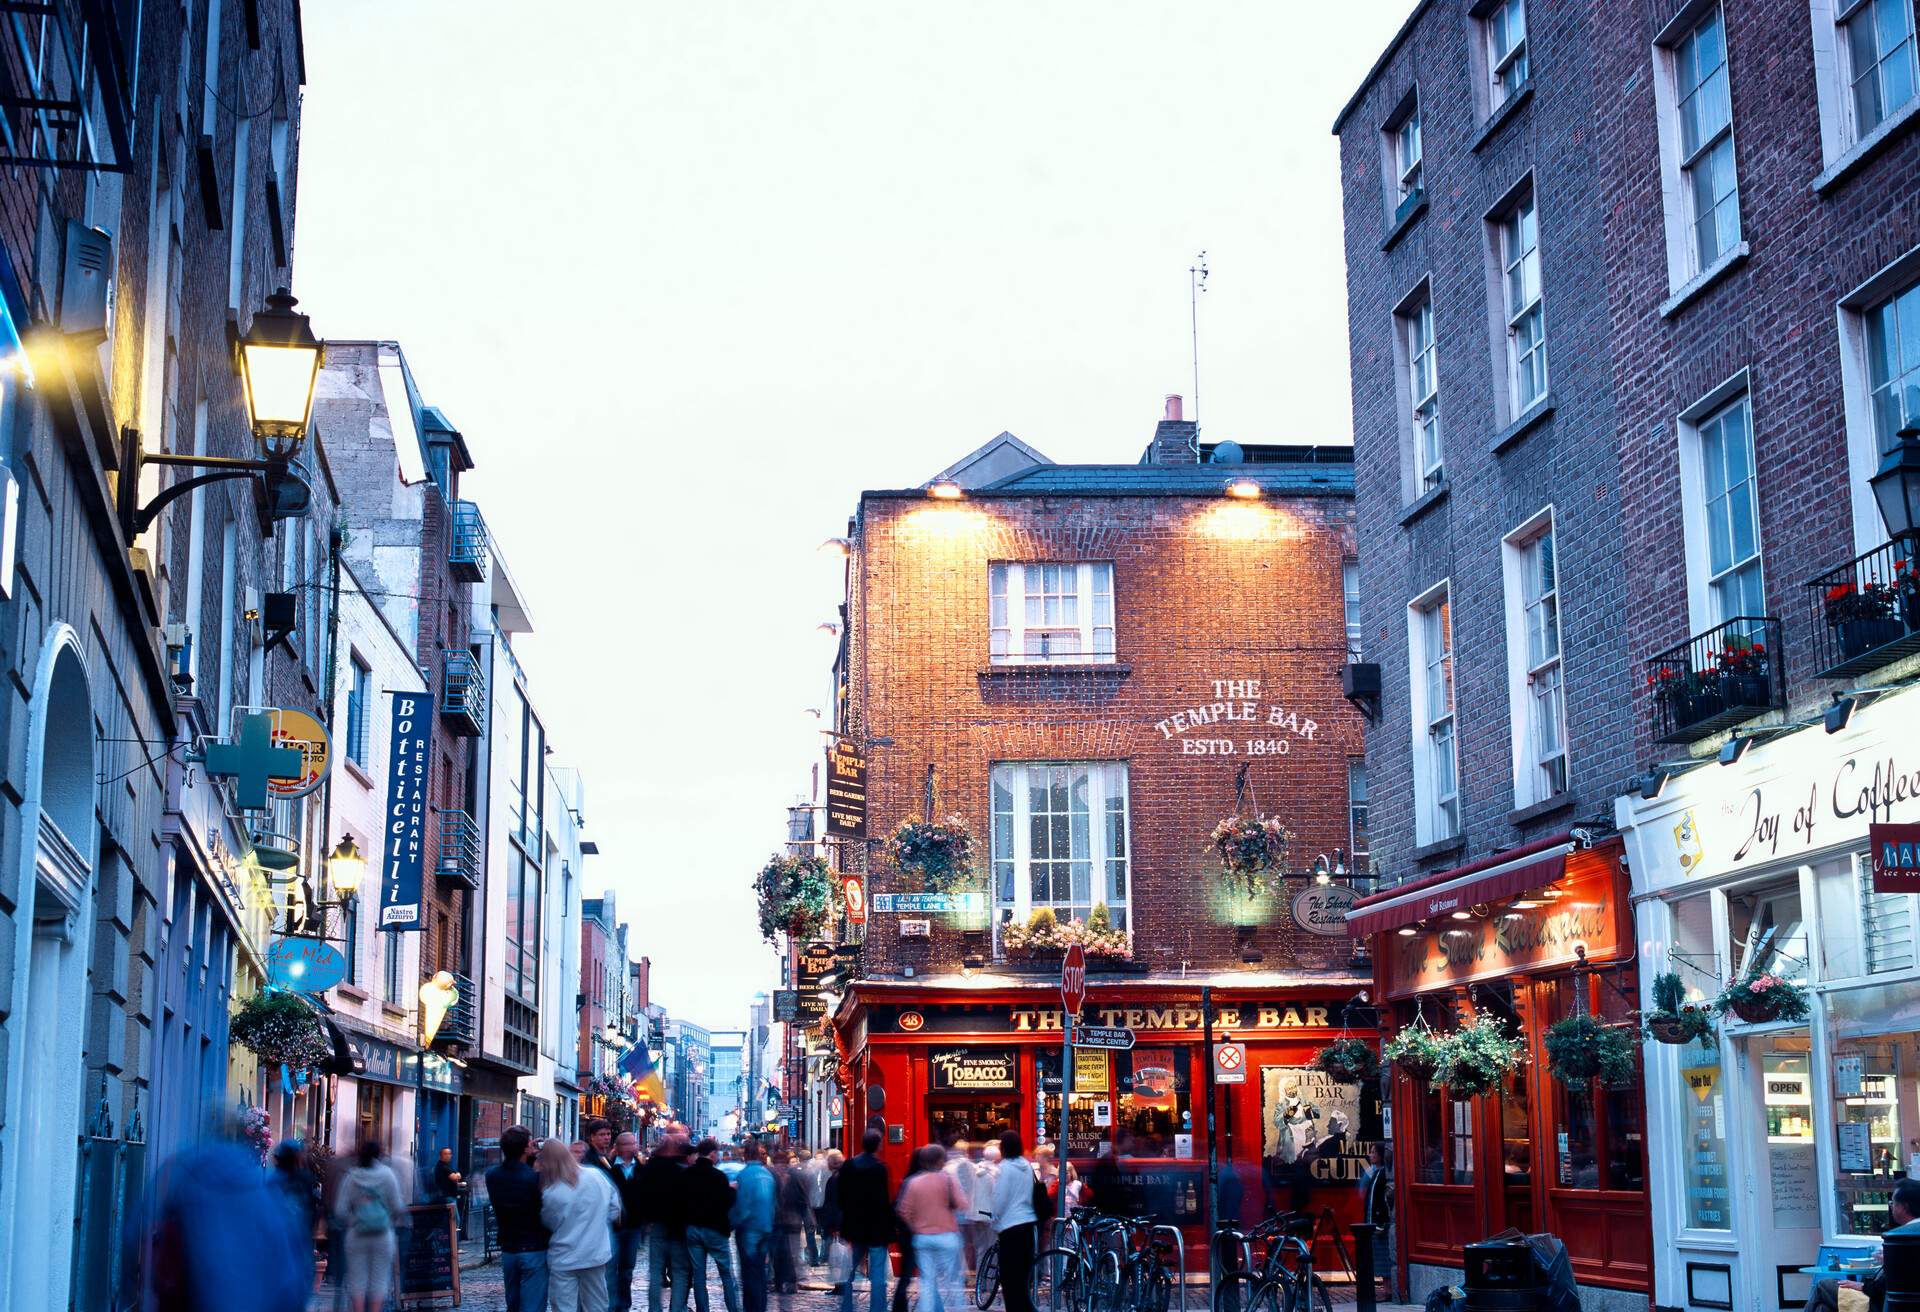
294,0,1411,1028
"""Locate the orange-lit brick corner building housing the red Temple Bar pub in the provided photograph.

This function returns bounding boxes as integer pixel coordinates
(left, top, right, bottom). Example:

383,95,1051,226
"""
817,398,1379,1252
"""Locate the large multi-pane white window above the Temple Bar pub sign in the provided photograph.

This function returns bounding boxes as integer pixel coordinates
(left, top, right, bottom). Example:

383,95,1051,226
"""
993,761,1129,928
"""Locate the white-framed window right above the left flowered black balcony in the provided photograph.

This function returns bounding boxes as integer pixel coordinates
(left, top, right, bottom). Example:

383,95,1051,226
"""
1682,390,1766,628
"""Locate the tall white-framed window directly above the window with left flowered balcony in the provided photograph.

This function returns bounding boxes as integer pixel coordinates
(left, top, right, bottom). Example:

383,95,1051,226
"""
1655,6,1740,286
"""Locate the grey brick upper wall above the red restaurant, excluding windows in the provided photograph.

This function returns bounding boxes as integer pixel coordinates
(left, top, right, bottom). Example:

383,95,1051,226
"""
1338,0,1632,891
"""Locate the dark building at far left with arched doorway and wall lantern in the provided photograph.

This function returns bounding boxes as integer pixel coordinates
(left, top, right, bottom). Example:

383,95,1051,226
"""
0,0,314,1308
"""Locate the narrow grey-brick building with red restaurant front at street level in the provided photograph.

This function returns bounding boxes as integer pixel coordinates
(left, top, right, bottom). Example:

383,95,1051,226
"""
1334,0,1653,1304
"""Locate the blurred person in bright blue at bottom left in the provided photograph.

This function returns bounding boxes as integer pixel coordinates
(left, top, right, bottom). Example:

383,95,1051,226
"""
149,1139,313,1312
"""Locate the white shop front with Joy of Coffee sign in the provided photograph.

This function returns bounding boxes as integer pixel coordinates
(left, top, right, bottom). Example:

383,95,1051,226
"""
1619,692,1920,1312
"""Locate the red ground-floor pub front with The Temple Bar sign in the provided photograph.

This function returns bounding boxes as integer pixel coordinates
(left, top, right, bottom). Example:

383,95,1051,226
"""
835,974,1382,1270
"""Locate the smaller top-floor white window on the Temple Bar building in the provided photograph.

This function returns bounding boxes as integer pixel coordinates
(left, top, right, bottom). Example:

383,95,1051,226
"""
987,561,1114,665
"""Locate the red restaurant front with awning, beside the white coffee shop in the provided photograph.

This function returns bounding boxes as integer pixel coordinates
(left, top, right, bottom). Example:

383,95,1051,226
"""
1348,834,1653,1306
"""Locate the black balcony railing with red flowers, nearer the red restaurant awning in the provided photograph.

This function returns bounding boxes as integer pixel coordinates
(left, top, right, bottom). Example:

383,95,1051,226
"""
1647,615,1788,743
